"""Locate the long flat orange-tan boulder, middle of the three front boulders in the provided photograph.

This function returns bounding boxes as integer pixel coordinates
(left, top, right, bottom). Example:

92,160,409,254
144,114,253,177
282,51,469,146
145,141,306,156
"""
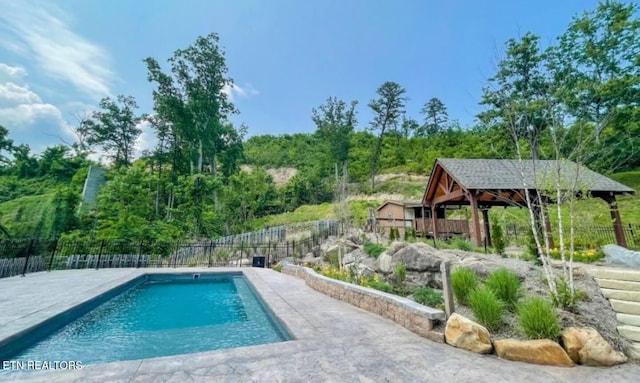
493,339,574,367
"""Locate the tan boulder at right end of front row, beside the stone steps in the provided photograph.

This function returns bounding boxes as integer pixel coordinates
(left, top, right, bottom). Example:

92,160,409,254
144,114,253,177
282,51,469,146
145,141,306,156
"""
562,327,627,366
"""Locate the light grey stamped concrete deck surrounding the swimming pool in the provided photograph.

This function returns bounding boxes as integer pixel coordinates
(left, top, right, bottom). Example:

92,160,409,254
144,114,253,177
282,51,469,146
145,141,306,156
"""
0,268,640,383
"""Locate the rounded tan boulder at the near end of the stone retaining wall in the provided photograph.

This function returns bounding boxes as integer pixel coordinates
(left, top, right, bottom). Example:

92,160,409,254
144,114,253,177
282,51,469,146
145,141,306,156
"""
444,313,493,354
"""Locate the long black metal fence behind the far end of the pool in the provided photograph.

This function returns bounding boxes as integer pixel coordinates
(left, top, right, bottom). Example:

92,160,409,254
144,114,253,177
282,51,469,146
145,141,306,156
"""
0,230,336,278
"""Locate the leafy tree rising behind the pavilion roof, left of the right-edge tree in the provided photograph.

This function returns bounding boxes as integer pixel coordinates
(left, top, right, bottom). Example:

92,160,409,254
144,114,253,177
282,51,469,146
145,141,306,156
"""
478,32,548,158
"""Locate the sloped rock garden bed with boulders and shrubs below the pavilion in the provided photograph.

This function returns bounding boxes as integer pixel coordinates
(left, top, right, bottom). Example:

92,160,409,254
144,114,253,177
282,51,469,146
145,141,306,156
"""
283,238,633,367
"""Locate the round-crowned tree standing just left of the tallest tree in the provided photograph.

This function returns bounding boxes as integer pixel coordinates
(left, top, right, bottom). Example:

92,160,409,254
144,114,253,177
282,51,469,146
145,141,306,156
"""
78,95,142,167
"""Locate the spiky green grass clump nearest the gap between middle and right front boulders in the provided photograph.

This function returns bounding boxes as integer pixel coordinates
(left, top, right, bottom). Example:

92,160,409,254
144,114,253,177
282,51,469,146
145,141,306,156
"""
518,297,560,340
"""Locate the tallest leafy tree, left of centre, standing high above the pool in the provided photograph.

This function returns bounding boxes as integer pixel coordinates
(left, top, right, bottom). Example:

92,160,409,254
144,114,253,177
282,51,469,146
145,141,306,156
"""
144,33,237,175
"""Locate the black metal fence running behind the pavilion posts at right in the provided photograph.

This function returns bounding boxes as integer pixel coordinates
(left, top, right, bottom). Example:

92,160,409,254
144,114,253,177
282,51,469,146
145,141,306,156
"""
505,223,640,249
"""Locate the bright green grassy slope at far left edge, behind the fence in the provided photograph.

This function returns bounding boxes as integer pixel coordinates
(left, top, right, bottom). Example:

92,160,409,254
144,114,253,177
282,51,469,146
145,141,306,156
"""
0,193,54,237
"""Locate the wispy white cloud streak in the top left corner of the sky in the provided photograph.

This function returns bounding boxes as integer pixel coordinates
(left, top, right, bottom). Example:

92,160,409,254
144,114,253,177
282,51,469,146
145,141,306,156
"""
0,0,115,99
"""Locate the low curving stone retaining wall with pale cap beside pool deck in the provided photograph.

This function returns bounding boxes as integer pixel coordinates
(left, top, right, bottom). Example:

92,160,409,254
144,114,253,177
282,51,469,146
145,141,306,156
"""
282,265,446,343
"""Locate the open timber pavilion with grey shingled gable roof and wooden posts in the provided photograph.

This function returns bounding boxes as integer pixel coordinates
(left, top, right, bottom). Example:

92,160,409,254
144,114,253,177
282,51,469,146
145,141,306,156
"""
422,158,635,247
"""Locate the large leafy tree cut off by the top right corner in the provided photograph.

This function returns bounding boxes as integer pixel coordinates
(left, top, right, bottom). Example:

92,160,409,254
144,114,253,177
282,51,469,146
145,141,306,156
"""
548,1,640,171
